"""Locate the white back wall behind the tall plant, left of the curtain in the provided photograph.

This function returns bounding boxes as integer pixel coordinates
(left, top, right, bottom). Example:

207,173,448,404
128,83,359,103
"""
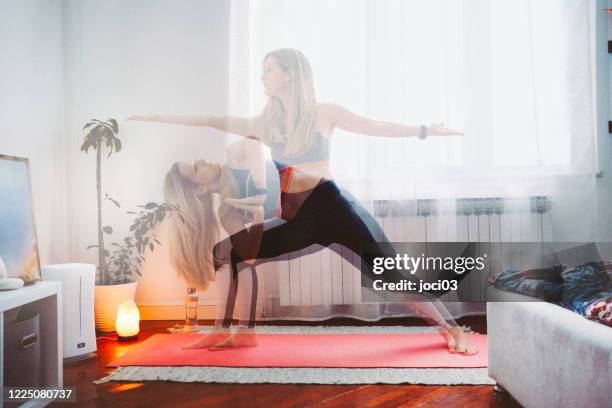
62,0,229,318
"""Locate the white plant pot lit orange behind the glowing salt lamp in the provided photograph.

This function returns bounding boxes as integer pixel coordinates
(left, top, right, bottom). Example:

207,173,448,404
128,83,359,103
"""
94,281,138,333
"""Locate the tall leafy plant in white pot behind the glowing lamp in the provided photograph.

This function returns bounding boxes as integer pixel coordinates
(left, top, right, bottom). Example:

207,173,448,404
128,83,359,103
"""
81,118,175,332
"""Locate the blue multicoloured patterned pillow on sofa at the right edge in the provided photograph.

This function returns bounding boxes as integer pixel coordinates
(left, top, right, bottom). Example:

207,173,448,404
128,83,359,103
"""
560,261,612,326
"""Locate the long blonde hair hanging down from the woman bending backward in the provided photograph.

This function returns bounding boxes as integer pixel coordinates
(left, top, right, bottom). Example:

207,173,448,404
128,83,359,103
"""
164,163,237,290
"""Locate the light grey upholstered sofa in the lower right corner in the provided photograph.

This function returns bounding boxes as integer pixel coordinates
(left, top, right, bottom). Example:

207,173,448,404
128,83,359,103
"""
487,286,612,408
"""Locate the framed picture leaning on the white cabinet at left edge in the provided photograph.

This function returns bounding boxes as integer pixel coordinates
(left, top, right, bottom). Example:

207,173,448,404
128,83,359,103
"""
0,155,41,284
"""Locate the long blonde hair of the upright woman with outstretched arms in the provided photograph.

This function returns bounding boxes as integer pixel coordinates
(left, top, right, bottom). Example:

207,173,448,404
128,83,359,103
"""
261,48,317,157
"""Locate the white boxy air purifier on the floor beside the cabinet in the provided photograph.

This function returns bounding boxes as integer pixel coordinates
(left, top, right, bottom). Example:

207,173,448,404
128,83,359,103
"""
42,263,96,361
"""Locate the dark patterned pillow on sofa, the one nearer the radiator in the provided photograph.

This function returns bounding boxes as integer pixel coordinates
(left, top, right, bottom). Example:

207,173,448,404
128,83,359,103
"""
492,264,567,303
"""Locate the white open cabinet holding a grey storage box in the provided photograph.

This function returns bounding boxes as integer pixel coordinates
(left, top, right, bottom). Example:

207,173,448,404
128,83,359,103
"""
0,281,64,407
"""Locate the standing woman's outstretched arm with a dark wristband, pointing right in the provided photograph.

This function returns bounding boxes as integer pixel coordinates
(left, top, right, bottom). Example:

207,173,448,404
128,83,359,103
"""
320,103,463,137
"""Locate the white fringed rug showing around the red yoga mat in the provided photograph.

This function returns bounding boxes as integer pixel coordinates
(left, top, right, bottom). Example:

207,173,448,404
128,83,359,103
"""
94,326,495,385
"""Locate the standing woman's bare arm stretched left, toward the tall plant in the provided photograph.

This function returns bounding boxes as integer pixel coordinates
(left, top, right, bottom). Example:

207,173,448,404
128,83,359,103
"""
127,113,261,137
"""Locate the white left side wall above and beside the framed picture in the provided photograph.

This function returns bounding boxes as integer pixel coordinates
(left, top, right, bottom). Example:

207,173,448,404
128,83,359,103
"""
0,0,68,264
